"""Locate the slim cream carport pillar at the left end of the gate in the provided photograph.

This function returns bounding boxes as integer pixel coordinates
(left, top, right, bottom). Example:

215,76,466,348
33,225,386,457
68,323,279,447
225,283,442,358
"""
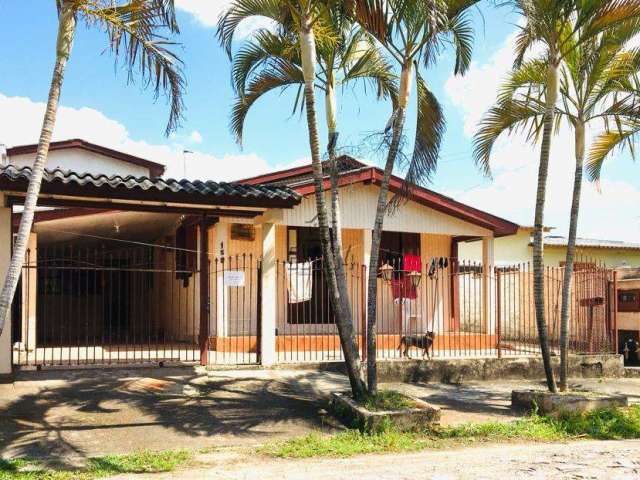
20,232,38,352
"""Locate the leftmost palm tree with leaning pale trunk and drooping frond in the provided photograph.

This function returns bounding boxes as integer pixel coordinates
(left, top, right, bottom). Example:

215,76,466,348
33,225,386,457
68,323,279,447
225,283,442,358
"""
0,0,184,342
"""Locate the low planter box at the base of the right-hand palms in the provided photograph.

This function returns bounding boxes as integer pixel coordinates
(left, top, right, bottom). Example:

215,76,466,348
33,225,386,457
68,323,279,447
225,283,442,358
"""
511,390,629,414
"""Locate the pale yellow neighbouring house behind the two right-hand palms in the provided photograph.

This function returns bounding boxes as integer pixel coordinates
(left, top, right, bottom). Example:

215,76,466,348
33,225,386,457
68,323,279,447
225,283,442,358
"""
459,226,640,268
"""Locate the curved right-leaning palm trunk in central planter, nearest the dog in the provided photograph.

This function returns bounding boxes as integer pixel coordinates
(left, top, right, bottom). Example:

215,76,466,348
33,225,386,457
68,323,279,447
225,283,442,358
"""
367,62,413,395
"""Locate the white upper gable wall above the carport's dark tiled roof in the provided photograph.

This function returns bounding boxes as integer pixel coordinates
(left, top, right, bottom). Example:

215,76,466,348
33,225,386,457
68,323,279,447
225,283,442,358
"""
9,148,149,177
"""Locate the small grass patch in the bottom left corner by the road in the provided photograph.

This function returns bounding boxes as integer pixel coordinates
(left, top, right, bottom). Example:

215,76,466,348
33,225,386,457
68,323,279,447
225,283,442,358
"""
0,450,192,480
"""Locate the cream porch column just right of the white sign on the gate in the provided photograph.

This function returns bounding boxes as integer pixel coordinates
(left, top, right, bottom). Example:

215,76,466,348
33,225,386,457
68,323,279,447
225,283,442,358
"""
259,223,278,366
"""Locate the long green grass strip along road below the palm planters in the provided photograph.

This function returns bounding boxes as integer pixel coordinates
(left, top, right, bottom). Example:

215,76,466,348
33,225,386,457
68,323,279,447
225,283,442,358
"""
259,405,640,458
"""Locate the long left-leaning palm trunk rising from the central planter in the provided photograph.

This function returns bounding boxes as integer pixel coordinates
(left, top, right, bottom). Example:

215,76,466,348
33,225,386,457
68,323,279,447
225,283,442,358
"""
300,27,365,398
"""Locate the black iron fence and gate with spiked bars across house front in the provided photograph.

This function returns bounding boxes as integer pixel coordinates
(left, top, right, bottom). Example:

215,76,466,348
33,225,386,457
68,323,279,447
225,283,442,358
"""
13,246,616,367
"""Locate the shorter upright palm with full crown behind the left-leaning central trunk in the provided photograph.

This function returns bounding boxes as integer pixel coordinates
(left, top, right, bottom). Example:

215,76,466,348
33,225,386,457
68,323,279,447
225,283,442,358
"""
231,15,397,264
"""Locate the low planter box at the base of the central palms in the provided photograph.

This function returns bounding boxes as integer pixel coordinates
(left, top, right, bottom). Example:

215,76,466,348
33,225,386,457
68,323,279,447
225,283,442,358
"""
331,393,440,432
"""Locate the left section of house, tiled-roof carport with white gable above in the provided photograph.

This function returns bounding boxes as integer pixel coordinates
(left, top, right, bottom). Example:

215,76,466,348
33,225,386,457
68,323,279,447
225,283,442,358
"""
0,140,300,373
